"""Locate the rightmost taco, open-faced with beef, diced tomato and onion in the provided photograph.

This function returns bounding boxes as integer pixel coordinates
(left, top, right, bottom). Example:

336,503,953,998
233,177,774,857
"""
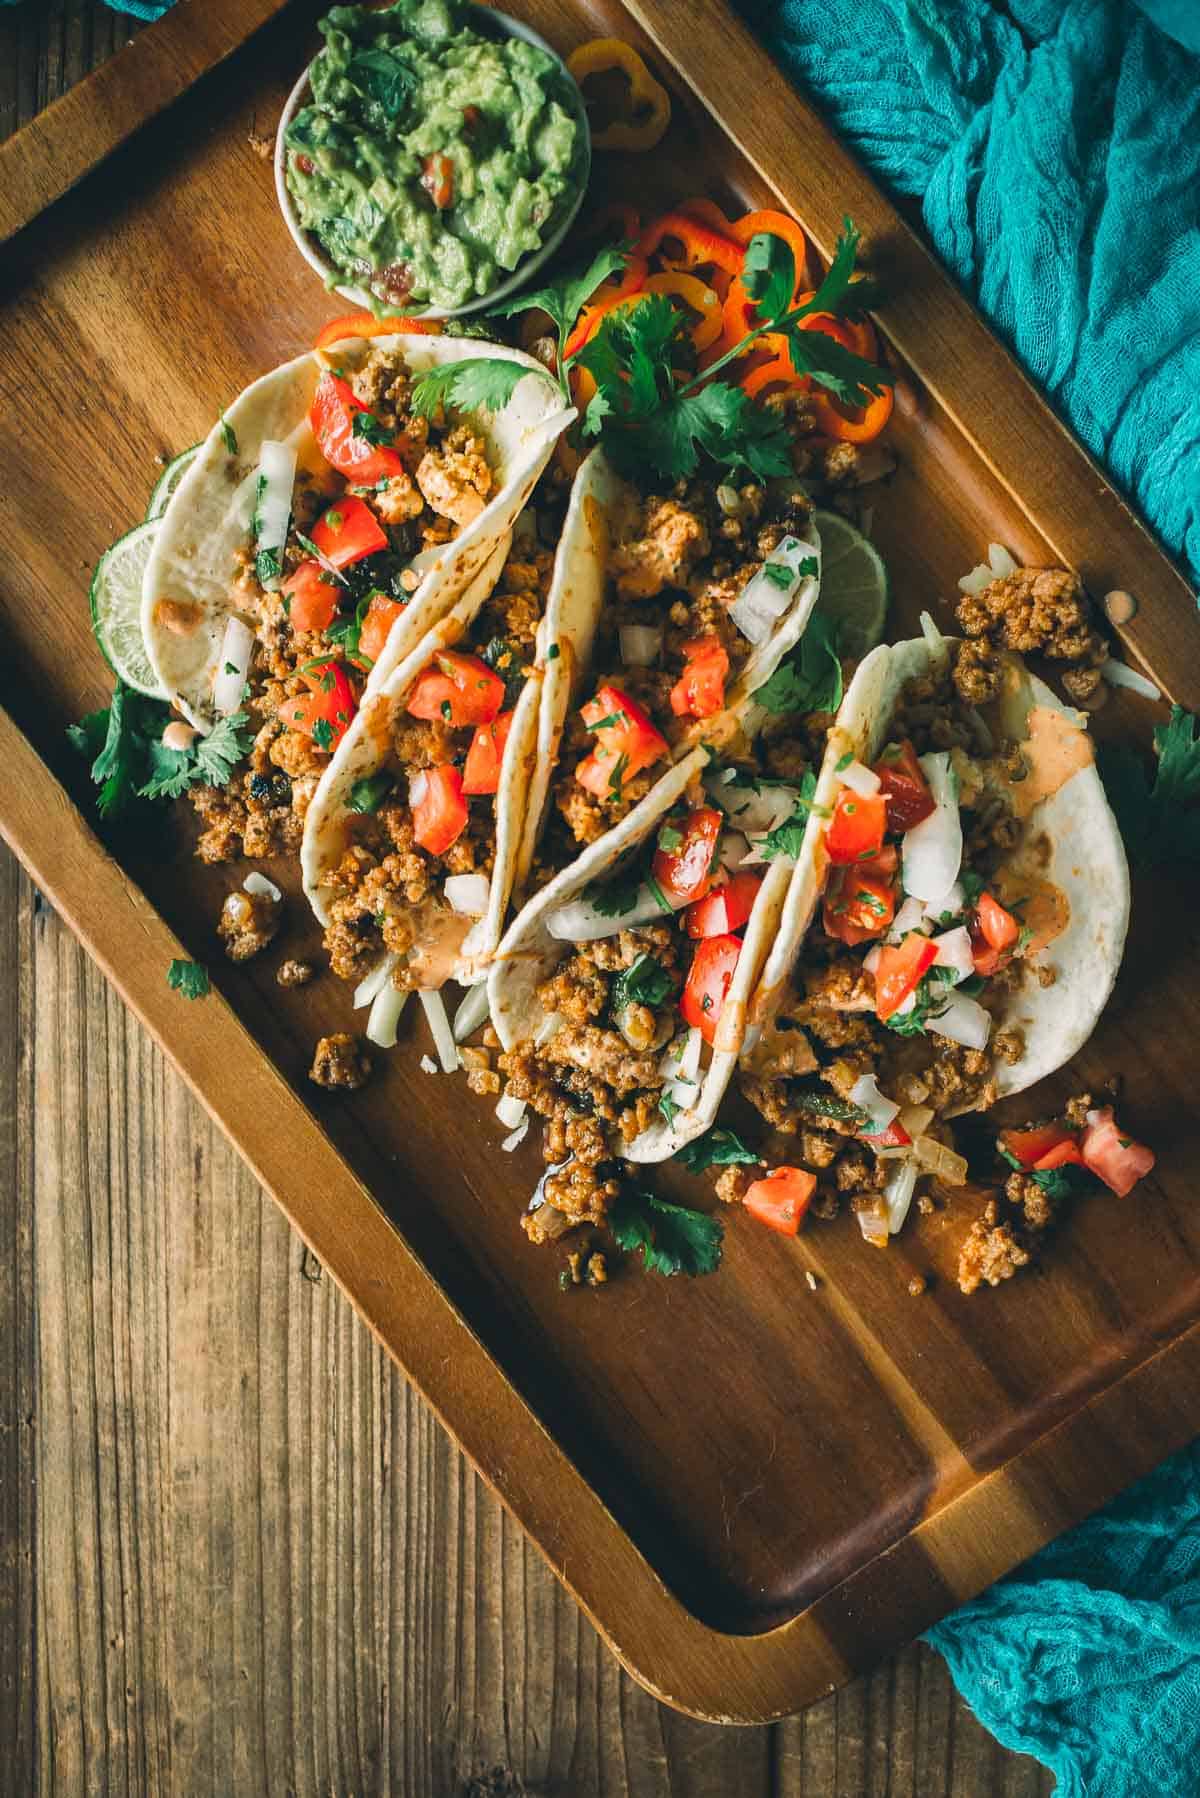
739,617,1130,1241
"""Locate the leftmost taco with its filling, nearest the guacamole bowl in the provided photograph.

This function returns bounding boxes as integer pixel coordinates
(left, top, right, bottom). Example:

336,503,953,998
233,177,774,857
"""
142,334,570,733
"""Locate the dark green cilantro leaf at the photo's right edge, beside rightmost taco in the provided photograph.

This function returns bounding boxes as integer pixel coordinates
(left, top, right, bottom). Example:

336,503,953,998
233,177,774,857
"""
1099,705,1200,868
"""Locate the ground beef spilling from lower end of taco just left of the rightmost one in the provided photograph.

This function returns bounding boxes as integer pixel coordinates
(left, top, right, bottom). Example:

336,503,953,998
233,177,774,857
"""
500,924,684,1241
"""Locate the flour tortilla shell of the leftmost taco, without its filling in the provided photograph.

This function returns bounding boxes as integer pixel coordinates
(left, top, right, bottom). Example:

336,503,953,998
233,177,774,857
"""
142,334,574,730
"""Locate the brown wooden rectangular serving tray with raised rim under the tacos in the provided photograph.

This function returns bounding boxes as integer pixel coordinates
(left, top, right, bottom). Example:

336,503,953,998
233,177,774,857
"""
0,0,1200,1722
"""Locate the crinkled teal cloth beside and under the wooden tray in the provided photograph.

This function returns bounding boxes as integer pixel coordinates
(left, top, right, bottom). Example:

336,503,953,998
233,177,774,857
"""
738,0,1200,1798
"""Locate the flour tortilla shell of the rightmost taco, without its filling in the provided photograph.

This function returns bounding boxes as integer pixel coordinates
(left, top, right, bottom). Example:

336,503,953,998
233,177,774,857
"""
745,628,1130,1099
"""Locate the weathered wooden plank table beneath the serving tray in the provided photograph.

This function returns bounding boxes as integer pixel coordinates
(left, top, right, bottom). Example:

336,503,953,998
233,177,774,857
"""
0,0,1052,1798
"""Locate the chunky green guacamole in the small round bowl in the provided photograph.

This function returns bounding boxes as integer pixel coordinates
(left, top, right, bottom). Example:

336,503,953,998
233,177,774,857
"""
286,0,587,311
